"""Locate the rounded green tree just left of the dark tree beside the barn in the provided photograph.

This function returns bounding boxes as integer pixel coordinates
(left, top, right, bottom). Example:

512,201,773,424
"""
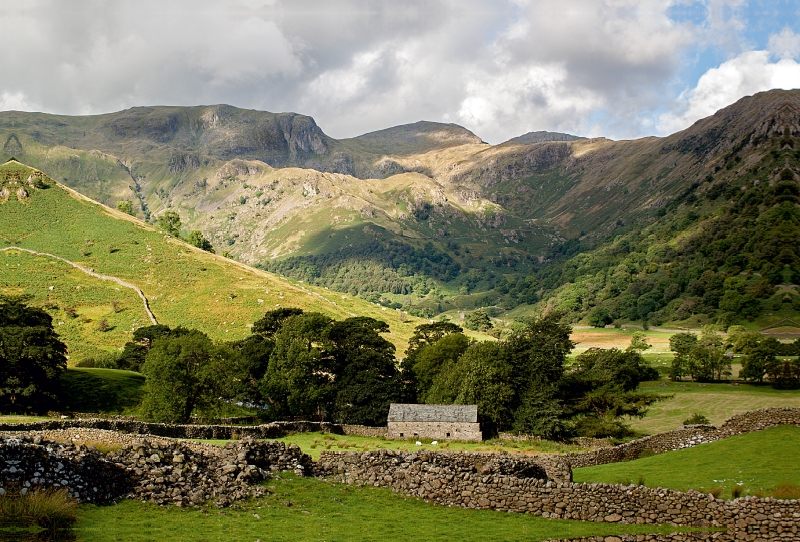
260,312,336,419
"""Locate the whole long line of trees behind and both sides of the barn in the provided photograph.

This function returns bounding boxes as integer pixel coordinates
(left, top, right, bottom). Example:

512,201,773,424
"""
118,308,659,439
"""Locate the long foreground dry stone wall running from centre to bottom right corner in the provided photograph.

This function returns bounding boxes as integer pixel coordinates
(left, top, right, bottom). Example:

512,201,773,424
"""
316,450,800,540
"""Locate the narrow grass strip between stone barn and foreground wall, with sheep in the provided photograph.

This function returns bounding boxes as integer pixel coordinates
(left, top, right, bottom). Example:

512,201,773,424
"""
191,433,581,460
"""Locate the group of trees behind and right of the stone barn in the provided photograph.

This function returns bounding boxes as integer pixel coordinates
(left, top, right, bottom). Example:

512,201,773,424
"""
403,314,658,439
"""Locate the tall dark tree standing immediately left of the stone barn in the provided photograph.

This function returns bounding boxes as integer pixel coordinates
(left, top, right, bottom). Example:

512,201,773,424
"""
328,316,405,426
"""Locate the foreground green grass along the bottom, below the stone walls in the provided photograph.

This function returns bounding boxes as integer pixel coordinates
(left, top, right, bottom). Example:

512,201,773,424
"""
75,474,712,542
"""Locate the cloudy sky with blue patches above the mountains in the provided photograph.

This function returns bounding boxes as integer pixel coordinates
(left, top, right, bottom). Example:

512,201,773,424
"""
0,0,800,143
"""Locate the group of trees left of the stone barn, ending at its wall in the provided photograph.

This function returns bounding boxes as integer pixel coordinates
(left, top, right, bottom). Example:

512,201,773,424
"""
127,308,408,425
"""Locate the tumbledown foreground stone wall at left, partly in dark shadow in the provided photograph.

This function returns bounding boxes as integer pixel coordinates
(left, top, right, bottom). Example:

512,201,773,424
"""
0,434,314,506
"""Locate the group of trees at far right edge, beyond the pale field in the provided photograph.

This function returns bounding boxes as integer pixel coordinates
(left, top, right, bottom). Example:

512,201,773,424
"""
669,326,800,389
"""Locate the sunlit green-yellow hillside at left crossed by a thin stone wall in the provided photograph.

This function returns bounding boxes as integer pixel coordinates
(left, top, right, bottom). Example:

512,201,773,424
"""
0,161,424,360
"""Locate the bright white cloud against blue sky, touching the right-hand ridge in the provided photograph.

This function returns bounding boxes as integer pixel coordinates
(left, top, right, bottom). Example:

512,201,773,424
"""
658,28,800,134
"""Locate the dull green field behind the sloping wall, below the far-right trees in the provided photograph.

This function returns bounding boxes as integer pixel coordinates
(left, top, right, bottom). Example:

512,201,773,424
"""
630,381,800,434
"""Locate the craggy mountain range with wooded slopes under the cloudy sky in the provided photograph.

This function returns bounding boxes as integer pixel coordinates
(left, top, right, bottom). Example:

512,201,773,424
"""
0,90,800,334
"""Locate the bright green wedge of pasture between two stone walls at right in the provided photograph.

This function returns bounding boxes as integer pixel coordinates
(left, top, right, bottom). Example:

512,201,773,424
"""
573,425,800,498
